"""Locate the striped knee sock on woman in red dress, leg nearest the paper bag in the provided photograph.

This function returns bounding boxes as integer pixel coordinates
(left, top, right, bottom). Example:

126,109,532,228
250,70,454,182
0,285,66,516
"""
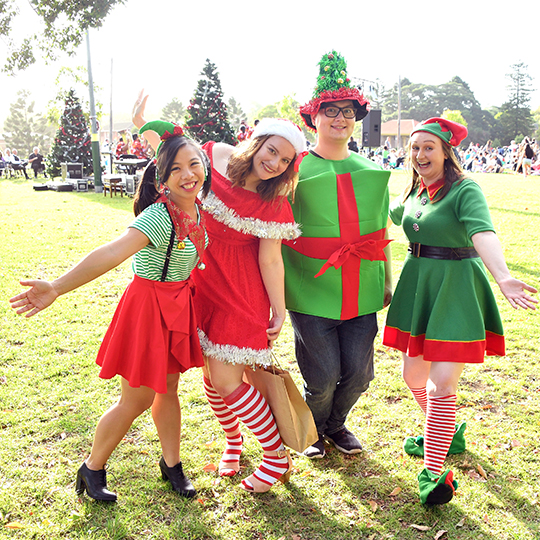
223,382,289,486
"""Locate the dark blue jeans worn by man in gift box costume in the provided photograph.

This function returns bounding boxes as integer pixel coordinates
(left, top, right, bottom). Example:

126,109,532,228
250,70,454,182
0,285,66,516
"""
289,311,377,435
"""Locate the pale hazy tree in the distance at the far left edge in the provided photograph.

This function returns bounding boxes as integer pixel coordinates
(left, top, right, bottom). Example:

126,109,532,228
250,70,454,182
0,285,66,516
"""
4,90,54,158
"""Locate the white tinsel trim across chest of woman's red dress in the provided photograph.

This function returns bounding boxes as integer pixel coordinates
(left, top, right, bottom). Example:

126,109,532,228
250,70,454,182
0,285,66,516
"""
202,191,302,240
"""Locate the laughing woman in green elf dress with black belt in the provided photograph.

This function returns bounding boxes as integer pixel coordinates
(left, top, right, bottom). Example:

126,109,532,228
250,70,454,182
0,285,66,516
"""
383,118,538,504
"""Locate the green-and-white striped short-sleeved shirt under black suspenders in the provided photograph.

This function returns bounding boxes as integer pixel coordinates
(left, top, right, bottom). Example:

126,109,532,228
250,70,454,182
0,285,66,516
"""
130,203,208,281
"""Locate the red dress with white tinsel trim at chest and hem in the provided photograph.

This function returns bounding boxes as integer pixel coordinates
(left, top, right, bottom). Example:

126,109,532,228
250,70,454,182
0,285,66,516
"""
192,142,300,365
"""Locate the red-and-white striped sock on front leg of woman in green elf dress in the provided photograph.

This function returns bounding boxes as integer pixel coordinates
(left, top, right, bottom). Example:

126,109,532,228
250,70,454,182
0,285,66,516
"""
424,394,457,474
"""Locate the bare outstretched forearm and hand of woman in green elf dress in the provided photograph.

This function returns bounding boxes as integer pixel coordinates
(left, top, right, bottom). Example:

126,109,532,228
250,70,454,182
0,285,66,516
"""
471,231,538,309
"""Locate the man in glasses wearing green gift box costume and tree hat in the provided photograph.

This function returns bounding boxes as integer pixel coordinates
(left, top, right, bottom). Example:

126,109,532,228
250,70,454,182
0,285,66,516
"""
283,51,392,458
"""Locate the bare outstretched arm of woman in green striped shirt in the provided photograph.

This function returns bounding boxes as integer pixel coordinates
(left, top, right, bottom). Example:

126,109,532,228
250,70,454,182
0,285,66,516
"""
9,228,149,317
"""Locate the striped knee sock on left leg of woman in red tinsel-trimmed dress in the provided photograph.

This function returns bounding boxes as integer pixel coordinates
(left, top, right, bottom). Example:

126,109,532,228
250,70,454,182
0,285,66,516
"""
203,377,242,476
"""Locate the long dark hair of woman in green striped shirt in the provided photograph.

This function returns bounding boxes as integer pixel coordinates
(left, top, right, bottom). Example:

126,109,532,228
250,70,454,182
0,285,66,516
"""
133,137,212,216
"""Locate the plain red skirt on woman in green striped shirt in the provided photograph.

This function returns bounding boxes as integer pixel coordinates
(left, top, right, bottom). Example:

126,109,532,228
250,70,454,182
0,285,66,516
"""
96,276,204,394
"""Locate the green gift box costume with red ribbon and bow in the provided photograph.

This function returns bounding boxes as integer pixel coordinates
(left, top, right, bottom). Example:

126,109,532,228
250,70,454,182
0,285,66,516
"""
283,153,390,320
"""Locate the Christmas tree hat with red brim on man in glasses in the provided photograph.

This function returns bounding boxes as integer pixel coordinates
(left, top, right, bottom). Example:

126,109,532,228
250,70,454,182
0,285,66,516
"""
300,51,369,131
